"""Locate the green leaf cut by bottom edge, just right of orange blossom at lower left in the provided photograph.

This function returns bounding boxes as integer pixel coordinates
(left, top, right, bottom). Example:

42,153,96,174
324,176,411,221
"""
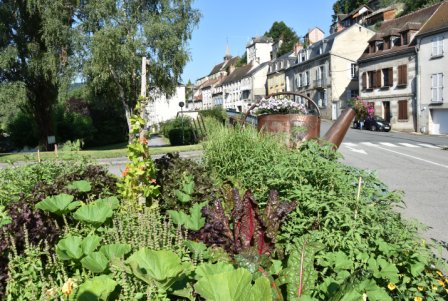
70,275,117,301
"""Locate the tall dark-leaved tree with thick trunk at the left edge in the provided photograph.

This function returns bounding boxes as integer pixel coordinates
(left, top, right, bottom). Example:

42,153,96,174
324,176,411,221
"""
0,0,77,149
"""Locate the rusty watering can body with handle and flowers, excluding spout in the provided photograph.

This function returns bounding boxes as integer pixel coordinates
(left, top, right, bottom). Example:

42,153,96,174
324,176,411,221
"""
251,92,320,147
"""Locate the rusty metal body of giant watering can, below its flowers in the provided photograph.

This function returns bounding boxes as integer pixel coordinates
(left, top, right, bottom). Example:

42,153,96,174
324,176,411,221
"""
258,114,320,147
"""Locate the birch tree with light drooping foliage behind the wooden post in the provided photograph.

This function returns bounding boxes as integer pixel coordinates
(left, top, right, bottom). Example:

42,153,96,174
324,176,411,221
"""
80,0,200,137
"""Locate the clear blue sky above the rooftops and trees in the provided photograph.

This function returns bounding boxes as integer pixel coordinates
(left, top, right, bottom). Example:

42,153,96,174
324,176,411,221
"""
182,0,335,84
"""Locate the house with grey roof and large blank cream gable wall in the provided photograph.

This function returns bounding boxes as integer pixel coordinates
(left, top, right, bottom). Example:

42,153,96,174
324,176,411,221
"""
286,24,374,120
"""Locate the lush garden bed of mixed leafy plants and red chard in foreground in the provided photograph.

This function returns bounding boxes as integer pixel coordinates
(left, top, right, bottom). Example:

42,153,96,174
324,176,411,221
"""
0,119,448,300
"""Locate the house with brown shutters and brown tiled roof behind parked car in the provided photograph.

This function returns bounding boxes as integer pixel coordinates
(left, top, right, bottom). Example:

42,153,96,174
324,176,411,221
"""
358,4,440,131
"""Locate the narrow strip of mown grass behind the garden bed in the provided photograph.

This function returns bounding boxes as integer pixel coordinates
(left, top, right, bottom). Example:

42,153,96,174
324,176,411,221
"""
0,143,202,163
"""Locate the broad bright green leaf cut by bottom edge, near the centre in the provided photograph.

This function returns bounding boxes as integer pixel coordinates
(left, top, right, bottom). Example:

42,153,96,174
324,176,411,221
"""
194,268,272,301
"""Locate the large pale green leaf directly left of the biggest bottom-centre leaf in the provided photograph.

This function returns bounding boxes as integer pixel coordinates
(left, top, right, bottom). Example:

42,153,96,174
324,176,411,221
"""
126,248,183,289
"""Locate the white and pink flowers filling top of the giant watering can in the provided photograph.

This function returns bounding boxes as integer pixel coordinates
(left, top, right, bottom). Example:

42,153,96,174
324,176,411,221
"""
254,97,308,115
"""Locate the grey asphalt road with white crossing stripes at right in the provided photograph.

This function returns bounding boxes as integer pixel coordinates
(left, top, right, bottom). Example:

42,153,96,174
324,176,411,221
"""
322,122,448,253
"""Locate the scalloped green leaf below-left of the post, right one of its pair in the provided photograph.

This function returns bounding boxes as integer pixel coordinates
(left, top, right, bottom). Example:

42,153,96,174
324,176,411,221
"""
73,201,113,226
